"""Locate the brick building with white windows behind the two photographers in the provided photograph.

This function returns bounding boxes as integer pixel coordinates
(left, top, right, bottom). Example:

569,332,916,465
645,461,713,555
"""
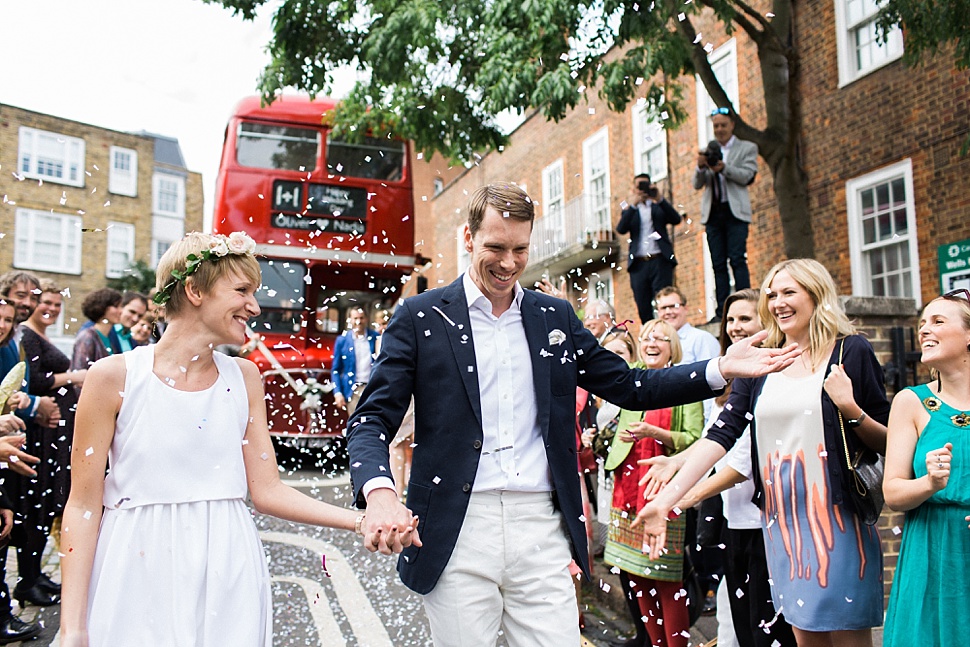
429,0,970,604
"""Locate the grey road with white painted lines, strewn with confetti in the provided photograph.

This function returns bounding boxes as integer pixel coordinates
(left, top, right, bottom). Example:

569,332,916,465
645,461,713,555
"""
17,471,780,647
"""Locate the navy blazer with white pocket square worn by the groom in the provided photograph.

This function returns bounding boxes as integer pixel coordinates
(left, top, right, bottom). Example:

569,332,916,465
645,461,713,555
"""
347,278,713,594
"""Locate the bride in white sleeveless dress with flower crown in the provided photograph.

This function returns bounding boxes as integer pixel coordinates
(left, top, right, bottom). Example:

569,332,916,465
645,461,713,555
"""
61,232,410,647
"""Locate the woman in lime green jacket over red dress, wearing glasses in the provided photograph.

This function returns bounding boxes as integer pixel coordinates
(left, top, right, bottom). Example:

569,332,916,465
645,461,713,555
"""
603,319,704,647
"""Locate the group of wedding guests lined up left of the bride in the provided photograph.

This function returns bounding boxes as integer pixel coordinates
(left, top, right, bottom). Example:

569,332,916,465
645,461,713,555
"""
0,271,163,644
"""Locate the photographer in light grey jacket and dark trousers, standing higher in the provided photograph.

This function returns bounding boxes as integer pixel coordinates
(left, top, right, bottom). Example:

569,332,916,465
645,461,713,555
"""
694,108,758,322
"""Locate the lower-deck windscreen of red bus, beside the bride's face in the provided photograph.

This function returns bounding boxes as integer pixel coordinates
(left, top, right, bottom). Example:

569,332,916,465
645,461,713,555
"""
250,259,307,335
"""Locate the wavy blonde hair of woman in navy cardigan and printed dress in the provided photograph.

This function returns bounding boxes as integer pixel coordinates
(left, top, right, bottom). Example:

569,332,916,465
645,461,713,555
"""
758,258,856,368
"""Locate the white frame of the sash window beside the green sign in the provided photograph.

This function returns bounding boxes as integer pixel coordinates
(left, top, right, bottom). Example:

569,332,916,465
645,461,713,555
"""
845,158,921,307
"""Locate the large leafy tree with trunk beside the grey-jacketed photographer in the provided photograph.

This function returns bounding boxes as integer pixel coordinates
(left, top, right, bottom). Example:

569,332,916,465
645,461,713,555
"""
212,0,814,257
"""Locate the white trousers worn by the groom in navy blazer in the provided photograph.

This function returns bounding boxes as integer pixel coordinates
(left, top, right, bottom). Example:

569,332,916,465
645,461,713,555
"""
424,491,579,647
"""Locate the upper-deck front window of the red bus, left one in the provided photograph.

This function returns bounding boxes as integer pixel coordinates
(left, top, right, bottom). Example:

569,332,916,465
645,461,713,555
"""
236,122,320,171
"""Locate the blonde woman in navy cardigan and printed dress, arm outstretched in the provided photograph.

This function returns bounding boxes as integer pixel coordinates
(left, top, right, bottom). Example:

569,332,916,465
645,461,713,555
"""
638,259,889,647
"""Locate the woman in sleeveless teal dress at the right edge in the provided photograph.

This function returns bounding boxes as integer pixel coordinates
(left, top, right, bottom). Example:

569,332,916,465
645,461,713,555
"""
883,290,970,647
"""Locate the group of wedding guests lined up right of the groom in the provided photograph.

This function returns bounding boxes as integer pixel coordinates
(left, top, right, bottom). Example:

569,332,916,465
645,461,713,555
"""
538,259,970,647
